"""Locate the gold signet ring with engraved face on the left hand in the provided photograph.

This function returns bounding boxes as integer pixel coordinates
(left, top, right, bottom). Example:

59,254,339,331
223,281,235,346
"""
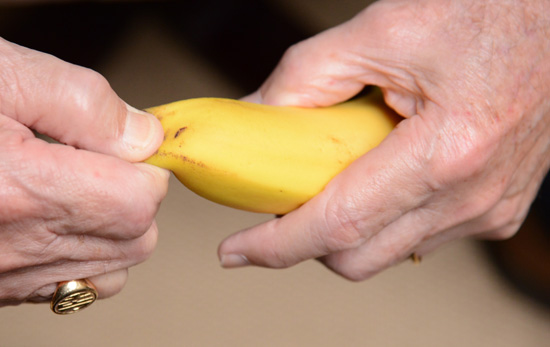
50,279,97,314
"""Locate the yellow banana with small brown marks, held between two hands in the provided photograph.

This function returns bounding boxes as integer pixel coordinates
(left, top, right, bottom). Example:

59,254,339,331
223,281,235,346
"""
146,92,398,214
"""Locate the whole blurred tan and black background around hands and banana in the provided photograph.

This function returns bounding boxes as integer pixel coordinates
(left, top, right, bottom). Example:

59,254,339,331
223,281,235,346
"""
0,0,550,347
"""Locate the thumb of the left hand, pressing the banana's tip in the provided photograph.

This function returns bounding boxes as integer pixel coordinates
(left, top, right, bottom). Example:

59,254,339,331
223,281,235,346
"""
0,39,163,162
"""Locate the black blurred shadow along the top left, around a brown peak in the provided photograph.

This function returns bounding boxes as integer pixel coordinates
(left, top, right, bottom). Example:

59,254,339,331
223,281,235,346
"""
0,0,310,92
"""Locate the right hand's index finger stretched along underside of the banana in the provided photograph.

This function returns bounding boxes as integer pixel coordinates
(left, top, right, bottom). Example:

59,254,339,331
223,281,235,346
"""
218,119,429,268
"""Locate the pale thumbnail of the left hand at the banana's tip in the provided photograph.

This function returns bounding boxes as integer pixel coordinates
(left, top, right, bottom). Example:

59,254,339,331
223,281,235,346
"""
122,105,161,158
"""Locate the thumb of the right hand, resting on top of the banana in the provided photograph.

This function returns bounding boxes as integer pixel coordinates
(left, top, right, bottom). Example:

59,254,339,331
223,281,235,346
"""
249,6,375,107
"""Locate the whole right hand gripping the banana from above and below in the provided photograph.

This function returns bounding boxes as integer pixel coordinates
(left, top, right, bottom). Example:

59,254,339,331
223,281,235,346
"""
219,0,550,280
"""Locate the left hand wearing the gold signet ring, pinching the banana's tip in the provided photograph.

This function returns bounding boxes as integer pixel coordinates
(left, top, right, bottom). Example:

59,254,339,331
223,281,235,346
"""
0,39,168,306
